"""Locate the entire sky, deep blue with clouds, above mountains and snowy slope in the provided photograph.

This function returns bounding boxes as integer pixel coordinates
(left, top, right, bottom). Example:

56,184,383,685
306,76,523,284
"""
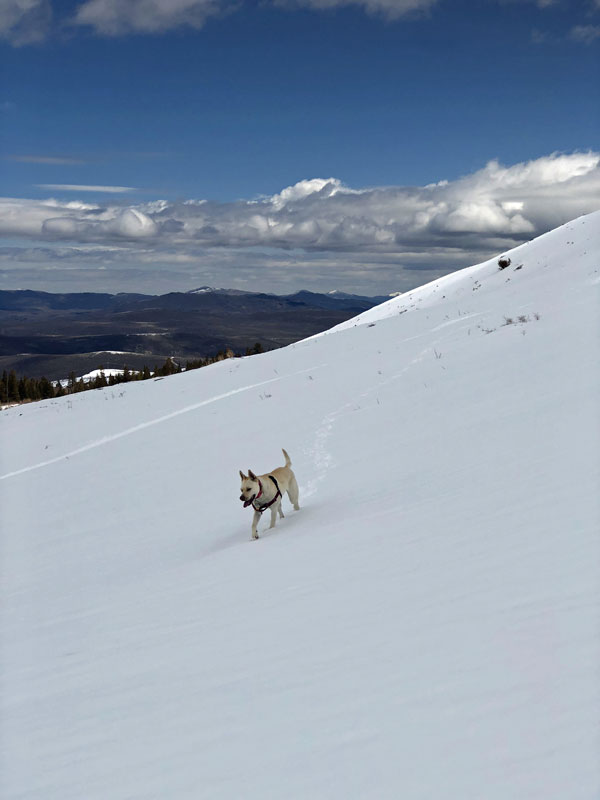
0,0,600,293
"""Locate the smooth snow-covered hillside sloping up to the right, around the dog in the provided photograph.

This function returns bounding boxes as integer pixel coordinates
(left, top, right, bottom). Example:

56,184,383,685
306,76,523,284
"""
0,213,600,800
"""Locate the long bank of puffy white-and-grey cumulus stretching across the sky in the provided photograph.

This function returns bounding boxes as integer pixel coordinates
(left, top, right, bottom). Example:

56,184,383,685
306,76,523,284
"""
0,152,600,251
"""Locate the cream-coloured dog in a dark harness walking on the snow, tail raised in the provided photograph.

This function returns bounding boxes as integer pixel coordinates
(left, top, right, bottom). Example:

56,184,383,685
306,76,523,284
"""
240,448,300,539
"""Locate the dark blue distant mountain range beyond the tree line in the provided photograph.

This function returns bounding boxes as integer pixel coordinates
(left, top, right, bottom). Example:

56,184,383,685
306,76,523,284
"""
0,286,389,379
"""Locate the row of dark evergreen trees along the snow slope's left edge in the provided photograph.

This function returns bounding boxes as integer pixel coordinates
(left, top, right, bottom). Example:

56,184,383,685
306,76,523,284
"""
0,342,263,404
